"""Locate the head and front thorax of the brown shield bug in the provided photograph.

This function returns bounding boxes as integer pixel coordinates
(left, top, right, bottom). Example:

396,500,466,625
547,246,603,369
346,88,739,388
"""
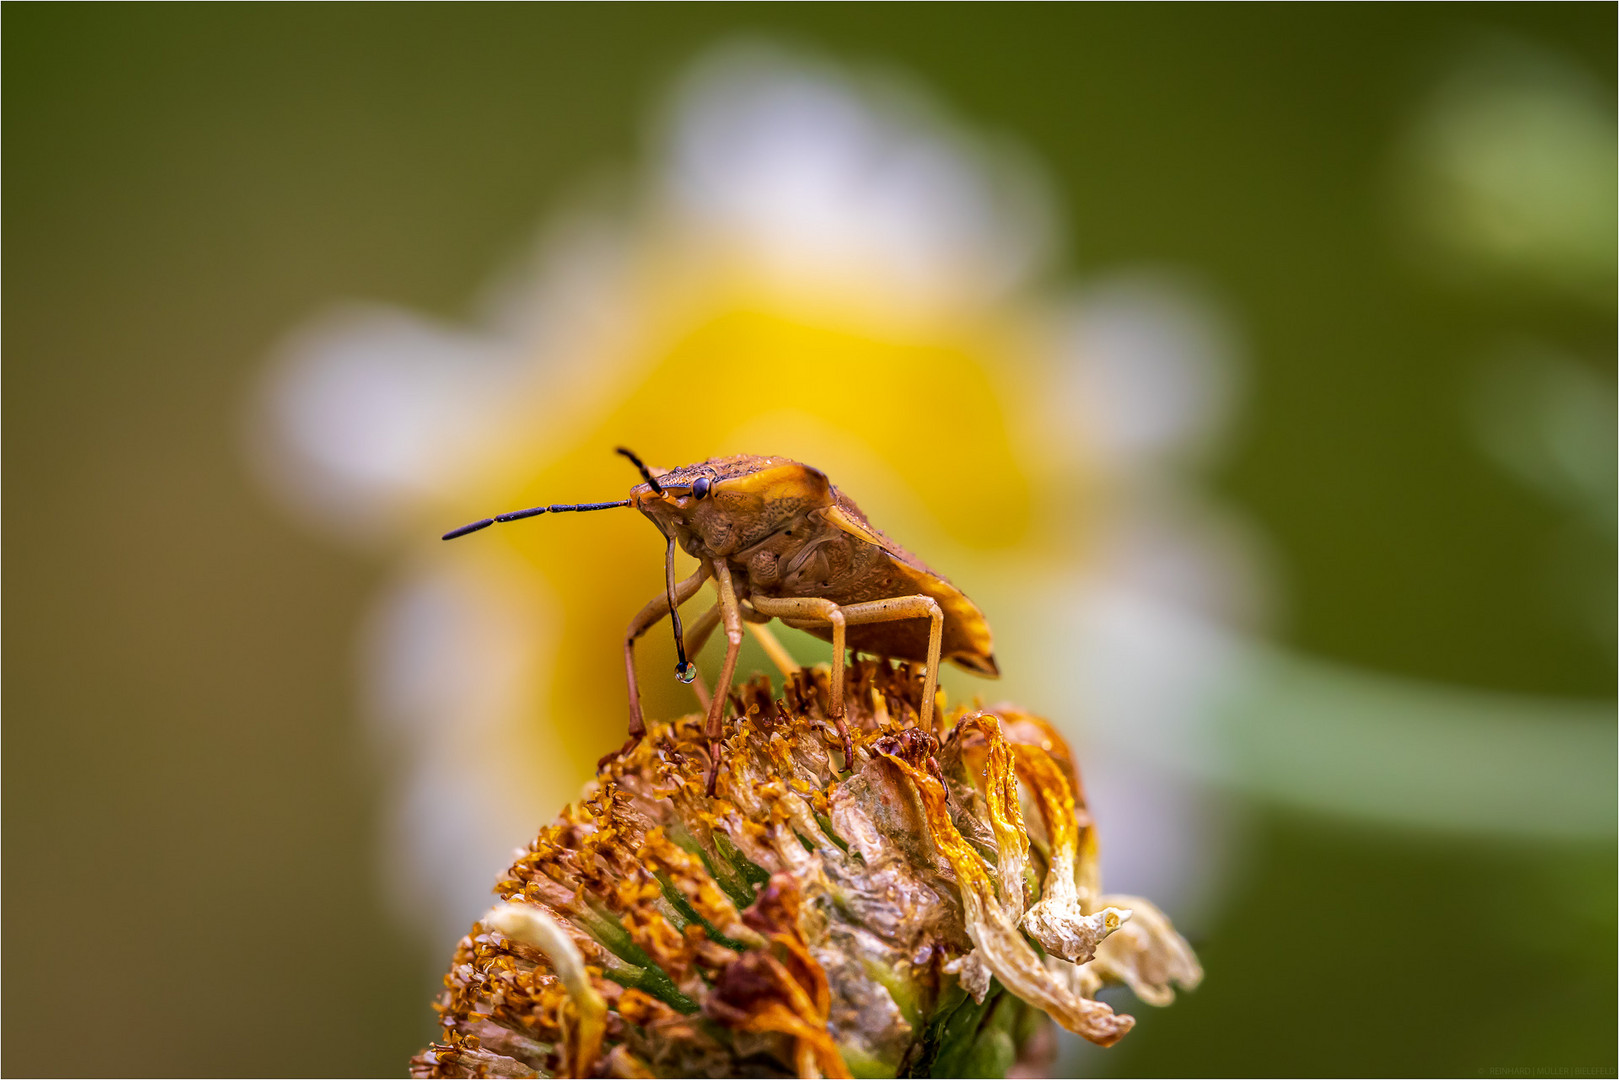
630,455,832,559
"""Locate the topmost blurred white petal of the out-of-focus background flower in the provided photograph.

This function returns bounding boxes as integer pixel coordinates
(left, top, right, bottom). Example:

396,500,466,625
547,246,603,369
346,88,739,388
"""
664,47,1052,304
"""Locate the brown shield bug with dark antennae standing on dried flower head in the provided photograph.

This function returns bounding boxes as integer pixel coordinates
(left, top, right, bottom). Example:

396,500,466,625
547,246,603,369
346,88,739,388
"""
444,449,1001,793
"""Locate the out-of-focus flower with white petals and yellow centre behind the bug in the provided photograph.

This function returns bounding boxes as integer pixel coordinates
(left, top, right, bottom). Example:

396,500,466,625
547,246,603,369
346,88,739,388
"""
251,45,1264,941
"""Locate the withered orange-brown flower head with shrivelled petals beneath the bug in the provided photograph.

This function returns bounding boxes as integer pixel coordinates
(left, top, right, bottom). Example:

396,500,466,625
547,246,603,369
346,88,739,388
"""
411,661,1201,1077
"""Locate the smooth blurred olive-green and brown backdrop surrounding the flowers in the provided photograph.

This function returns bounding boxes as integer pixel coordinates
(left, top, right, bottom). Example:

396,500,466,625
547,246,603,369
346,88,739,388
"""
3,3,1619,1075
